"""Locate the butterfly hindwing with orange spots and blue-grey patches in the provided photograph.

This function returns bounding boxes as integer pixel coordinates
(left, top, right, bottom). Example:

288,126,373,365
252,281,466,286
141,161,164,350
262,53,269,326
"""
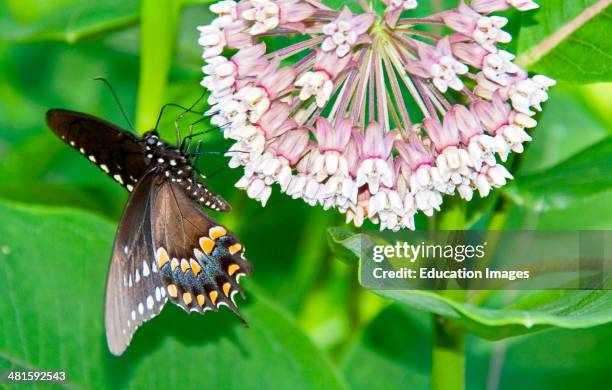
152,181,251,314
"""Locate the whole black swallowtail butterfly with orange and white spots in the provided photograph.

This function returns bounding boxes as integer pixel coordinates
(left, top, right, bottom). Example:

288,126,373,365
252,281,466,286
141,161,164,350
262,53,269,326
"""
47,110,251,355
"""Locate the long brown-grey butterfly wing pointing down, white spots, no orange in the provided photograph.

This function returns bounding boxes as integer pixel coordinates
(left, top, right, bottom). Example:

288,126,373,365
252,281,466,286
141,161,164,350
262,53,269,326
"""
105,174,168,355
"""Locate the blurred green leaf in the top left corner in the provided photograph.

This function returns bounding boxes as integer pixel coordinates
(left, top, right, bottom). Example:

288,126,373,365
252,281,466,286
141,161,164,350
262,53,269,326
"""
0,0,138,43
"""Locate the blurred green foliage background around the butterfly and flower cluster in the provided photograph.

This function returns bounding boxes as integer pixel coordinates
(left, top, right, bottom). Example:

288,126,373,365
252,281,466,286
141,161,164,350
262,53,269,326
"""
0,0,612,389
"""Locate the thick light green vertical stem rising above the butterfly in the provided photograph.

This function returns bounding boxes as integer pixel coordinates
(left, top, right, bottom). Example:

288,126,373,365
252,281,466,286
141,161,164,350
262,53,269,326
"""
136,0,181,133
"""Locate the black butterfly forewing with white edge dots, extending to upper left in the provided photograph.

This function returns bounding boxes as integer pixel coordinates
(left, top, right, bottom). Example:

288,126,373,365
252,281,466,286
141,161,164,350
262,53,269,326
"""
47,109,146,191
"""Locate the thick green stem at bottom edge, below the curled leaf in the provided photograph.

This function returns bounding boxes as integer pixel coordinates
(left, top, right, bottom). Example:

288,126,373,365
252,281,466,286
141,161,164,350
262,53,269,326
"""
431,315,465,390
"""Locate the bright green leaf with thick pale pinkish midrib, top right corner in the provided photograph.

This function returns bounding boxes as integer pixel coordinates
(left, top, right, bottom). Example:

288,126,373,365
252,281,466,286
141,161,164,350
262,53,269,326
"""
517,0,612,82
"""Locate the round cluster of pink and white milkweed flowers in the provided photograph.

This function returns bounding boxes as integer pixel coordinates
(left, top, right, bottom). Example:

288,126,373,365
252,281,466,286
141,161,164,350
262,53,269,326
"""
199,0,555,230
